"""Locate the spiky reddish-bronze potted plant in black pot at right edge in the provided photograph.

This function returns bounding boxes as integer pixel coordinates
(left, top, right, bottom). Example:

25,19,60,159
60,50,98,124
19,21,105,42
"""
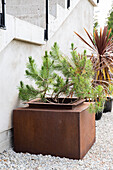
75,26,113,119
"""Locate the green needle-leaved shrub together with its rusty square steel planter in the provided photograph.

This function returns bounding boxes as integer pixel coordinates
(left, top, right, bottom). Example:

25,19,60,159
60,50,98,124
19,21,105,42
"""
13,43,104,159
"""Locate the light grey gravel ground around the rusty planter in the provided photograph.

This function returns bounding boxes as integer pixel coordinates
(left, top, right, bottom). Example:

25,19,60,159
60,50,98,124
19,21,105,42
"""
0,112,113,170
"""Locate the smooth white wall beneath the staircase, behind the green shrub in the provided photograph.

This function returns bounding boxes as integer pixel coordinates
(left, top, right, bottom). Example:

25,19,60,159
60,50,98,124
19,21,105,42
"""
0,0,94,151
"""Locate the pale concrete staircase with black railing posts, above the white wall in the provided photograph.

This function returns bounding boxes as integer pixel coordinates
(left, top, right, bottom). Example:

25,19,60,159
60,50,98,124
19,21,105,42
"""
0,0,97,51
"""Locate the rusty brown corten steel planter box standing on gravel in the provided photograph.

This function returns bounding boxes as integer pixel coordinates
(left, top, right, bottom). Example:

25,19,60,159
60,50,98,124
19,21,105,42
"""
13,99,95,159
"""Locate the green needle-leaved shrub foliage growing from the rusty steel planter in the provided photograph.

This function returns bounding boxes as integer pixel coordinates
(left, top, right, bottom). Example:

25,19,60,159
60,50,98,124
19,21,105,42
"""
19,43,104,111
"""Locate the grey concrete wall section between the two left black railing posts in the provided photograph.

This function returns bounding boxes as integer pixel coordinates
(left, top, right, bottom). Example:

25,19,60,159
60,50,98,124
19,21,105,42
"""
6,0,46,28
